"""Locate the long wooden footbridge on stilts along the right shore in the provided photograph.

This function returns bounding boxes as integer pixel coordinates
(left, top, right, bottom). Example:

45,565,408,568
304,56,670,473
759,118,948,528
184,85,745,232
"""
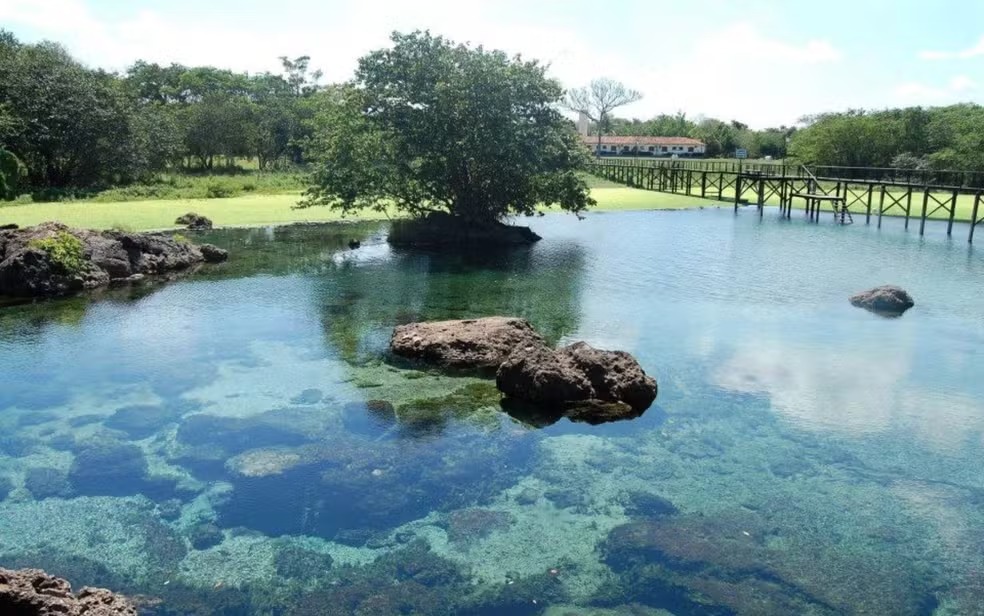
591,159,984,242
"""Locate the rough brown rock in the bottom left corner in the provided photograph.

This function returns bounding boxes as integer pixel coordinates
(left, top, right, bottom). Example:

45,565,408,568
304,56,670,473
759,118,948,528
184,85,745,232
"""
0,569,137,616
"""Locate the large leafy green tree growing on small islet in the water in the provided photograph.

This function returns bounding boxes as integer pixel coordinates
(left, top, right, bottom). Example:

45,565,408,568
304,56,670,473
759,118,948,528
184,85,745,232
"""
305,31,593,222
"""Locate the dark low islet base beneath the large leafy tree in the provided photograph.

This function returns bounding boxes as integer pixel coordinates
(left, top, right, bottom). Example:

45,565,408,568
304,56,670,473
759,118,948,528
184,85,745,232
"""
387,213,541,248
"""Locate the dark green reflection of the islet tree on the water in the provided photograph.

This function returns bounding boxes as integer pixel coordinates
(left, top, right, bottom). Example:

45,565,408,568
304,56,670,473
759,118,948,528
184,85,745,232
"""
317,244,585,361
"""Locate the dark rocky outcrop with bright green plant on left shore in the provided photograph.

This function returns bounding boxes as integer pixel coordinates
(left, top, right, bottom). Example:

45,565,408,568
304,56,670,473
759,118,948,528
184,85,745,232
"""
0,222,228,297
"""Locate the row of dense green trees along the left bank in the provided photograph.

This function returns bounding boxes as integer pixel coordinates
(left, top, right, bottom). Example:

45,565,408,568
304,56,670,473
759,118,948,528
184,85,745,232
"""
0,30,320,195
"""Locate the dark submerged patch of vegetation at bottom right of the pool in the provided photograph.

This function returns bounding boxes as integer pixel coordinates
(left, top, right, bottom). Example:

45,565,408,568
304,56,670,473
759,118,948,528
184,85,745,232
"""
595,511,937,616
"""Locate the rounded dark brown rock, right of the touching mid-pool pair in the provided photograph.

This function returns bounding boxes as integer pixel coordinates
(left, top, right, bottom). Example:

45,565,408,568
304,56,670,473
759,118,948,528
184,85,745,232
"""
495,342,656,422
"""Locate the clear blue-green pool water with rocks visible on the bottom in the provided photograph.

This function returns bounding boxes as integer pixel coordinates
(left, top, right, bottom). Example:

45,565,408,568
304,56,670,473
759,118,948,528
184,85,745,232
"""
0,210,984,614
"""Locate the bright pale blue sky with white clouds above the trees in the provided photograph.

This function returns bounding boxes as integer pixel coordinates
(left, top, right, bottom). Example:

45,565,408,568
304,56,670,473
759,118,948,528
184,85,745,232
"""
0,0,984,128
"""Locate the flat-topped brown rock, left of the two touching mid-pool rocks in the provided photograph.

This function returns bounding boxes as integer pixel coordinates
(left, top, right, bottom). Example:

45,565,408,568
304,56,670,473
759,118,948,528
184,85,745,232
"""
390,317,546,373
